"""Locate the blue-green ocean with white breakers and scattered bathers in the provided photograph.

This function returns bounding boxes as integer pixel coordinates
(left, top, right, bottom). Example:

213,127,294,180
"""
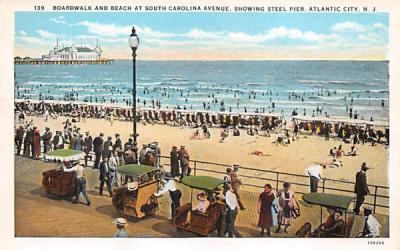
15,60,389,119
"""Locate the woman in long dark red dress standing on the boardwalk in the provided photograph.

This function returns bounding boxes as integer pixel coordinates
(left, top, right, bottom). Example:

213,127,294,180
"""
257,184,275,236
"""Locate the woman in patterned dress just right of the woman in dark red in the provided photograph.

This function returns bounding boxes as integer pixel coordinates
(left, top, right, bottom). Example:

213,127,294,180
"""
275,182,294,233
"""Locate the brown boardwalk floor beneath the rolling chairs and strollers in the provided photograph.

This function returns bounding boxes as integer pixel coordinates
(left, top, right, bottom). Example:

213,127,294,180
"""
15,157,388,237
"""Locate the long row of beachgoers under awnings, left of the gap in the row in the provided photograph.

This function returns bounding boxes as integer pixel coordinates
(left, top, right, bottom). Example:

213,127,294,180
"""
15,101,281,129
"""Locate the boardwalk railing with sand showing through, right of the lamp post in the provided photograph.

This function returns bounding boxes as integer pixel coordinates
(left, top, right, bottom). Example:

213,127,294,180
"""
161,156,389,214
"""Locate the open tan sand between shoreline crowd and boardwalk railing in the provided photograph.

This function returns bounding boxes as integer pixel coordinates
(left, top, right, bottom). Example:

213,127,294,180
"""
20,116,388,188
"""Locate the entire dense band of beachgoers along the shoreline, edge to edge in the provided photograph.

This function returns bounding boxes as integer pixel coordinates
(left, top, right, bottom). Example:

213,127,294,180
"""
15,101,389,150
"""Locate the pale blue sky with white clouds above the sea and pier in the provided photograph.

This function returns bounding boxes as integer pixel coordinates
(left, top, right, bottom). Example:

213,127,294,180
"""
15,12,388,60
